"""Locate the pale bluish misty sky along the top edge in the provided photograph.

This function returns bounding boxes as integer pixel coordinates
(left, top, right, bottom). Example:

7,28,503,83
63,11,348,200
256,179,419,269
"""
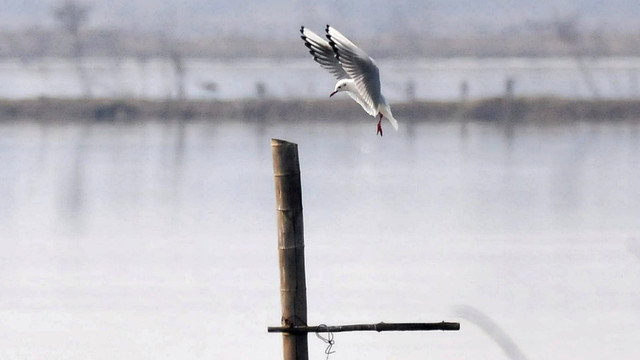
0,0,640,37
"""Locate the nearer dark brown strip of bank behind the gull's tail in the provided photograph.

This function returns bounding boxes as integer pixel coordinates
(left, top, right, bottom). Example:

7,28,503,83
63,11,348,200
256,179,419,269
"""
0,98,640,123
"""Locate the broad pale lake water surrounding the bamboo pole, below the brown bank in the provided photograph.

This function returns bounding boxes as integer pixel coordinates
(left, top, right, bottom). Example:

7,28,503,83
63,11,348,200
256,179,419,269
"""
0,119,640,360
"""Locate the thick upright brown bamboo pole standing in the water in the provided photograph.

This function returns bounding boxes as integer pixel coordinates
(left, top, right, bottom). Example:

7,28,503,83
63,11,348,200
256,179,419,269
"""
271,139,309,360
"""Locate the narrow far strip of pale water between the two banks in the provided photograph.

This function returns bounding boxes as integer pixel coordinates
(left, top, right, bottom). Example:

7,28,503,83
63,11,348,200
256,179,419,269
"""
0,57,640,102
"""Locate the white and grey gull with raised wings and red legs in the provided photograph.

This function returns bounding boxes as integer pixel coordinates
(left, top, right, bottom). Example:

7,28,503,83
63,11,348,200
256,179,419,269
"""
300,25,398,136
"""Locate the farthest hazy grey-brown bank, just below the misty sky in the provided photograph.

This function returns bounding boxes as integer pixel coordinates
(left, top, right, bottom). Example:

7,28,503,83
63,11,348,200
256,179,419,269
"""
0,29,640,60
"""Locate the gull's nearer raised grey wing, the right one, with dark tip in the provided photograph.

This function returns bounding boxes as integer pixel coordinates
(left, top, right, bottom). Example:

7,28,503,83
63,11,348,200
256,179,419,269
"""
326,25,381,109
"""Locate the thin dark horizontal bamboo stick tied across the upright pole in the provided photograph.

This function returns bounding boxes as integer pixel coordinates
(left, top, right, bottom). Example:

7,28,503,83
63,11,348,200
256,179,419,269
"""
267,321,460,334
